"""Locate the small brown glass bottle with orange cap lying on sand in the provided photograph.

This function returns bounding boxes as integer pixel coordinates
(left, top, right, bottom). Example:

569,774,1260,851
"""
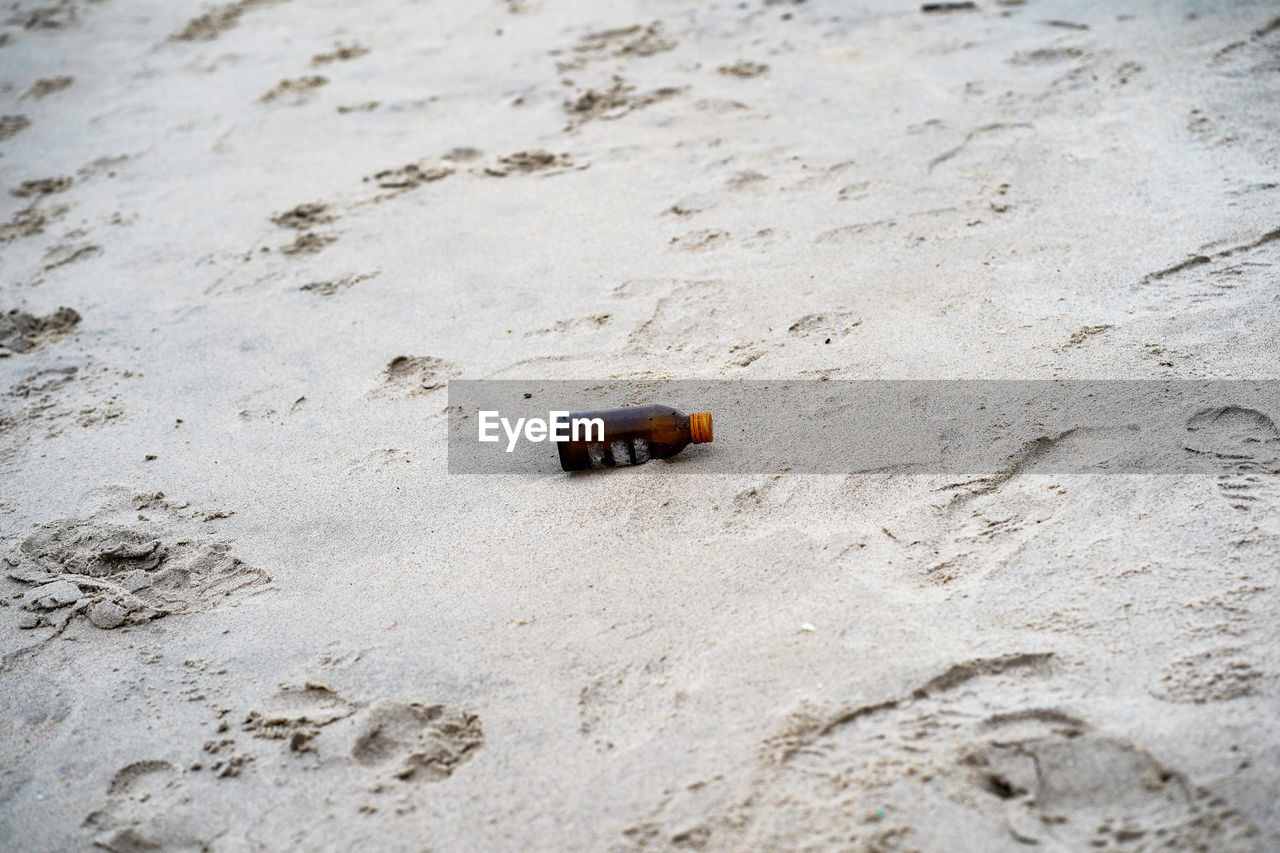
557,406,712,471
